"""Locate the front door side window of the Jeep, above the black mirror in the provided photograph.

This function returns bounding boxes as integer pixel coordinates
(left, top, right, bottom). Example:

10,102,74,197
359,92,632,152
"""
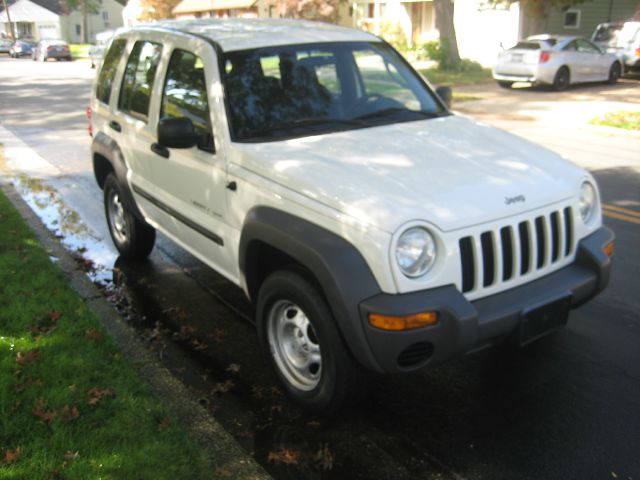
160,50,214,152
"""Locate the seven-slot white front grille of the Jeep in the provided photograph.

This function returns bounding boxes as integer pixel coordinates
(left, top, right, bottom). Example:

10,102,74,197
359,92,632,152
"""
459,207,573,293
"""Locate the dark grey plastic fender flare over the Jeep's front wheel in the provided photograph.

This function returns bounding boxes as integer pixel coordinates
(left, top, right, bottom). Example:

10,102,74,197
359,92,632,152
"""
239,207,380,371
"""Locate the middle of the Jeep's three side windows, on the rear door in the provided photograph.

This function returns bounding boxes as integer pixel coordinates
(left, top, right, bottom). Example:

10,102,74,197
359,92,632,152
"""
118,42,162,121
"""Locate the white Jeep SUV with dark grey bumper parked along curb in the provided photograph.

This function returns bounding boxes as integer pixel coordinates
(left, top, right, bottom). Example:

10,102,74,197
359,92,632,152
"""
89,20,613,413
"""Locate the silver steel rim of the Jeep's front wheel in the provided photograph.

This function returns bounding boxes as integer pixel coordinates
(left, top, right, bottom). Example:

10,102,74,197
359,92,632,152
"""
267,300,322,391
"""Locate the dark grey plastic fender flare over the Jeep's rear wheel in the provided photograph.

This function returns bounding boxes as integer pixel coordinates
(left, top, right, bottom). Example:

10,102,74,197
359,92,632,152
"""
91,132,144,220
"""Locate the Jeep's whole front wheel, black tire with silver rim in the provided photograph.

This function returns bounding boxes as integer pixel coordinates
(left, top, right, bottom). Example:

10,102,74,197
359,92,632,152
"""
256,270,366,415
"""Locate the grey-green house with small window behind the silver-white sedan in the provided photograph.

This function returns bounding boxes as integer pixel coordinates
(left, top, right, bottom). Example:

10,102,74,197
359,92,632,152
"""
521,0,640,38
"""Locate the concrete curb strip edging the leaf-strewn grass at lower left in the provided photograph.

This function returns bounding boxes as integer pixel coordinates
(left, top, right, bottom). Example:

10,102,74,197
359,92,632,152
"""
0,173,271,480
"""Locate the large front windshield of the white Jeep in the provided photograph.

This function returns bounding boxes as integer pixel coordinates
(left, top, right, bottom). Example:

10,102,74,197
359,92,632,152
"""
223,42,447,142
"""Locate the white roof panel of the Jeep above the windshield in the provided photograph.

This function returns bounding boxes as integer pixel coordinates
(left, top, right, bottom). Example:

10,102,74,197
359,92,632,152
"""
133,18,380,51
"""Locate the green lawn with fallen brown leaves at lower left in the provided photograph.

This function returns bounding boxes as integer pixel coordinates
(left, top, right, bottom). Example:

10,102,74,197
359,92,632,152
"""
0,183,213,480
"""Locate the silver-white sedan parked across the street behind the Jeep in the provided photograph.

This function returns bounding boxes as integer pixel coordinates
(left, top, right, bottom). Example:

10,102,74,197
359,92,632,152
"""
493,35,622,90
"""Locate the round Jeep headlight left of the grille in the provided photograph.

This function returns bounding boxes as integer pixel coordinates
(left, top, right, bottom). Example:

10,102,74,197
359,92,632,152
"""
396,227,437,278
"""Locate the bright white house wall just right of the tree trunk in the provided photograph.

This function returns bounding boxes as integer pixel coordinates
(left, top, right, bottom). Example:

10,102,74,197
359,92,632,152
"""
454,0,520,66
